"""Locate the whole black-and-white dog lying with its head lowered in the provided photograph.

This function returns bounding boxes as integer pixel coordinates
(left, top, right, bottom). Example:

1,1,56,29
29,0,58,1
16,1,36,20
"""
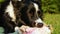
0,0,43,34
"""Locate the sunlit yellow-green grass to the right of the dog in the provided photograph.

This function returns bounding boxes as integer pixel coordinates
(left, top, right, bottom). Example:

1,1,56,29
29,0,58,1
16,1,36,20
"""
44,13,60,34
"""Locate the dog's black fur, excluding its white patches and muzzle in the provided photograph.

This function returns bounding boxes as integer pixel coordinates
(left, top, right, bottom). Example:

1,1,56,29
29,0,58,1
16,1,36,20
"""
0,0,43,34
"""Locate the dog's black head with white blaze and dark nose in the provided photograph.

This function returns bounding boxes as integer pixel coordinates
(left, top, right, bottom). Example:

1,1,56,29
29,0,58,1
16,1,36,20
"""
13,2,43,27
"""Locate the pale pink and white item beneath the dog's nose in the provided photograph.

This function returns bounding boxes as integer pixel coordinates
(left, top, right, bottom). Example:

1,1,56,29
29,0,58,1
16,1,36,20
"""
23,27,50,34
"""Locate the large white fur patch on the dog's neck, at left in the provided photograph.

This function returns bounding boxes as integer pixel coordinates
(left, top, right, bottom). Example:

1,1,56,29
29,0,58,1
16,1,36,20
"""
5,1,16,21
